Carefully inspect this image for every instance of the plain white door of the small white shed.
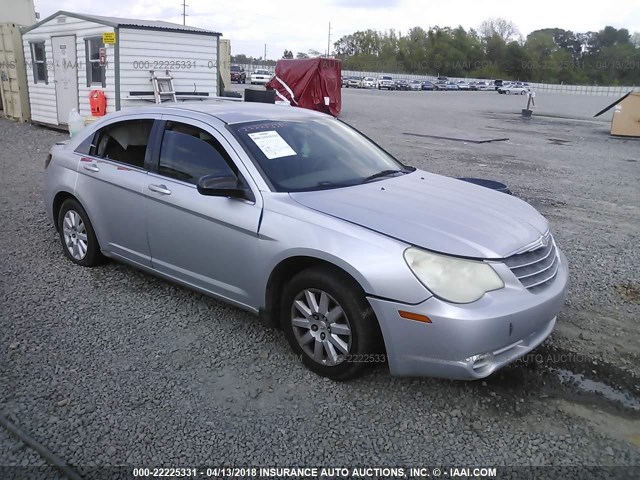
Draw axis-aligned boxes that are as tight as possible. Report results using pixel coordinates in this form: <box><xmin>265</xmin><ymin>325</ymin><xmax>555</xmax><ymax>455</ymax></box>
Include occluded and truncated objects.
<box><xmin>51</xmin><ymin>35</ymin><xmax>78</xmax><ymax>125</ymax></box>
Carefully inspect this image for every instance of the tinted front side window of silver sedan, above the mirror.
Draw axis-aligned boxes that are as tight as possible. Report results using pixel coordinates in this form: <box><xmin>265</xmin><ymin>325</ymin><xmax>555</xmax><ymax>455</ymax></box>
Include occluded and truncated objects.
<box><xmin>158</xmin><ymin>122</ymin><xmax>237</xmax><ymax>185</ymax></box>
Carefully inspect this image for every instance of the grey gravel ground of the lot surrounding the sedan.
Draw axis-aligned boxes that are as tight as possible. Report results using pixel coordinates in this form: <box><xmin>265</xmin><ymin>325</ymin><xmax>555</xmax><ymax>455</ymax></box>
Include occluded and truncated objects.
<box><xmin>0</xmin><ymin>89</ymin><xmax>640</xmax><ymax>476</ymax></box>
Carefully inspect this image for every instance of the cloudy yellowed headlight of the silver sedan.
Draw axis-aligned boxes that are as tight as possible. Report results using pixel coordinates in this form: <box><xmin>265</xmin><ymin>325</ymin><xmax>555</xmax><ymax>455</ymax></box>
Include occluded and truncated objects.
<box><xmin>404</xmin><ymin>247</ymin><xmax>504</xmax><ymax>303</ymax></box>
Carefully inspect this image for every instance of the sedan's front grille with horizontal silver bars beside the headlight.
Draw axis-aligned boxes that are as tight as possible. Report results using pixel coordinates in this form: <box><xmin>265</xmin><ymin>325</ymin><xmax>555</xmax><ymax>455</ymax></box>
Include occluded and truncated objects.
<box><xmin>504</xmin><ymin>232</ymin><xmax>559</xmax><ymax>293</ymax></box>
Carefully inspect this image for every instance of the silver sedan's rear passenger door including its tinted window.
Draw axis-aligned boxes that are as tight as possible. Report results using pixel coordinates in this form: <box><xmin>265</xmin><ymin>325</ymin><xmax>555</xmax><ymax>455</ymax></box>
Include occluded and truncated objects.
<box><xmin>76</xmin><ymin>115</ymin><xmax>159</xmax><ymax>267</ymax></box>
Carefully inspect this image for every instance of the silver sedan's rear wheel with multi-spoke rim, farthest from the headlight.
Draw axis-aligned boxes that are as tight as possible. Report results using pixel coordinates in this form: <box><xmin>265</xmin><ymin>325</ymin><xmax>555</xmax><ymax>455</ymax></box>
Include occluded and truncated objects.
<box><xmin>58</xmin><ymin>198</ymin><xmax>103</xmax><ymax>267</ymax></box>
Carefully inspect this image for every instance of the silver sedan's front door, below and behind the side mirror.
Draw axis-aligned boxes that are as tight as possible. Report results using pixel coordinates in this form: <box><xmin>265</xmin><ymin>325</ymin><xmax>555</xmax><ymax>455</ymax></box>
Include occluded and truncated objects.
<box><xmin>144</xmin><ymin>115</ymin><xmax>262</xmax><ymax>306</ymax></box>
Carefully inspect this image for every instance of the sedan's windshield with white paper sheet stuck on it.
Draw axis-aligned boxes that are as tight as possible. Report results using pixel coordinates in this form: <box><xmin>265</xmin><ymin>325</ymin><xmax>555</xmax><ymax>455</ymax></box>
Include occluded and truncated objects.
<box><xmin>228</xmin><ymin>118</ymin><xmax>411</xmax><ymax>192</ymax></box>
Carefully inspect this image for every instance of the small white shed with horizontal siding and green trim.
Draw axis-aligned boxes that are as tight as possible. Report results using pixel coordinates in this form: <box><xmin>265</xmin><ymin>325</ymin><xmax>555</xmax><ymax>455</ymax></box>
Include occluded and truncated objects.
<box><xmin>22</xmin><ymin>11</ymin><xmax>221</xmax><ymax>126</ymax></box>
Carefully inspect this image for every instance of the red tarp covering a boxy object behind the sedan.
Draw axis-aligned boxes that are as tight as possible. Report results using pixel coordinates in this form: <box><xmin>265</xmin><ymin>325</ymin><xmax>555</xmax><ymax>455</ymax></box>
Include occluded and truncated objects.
<box><xmin>266</xmin><ymin>58</ymin><xmax>342</xmax><ymax>117</ymax></box>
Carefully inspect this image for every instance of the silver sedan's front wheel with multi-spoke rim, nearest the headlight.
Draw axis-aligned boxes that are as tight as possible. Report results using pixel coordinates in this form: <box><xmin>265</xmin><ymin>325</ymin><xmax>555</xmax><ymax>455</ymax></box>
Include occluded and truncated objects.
<box><xmin>281</xmin><ymin>267</ymin><xmax>384</xmax><ymax>381</ymax></box>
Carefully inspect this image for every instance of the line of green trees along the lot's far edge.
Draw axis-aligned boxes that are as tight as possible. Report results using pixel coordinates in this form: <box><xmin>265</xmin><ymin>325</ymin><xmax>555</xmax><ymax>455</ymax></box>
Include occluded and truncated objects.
<box><xmin>330</xmin><ymin>18</ymin><xmax>640</xmax><ymax>85</ymax></box>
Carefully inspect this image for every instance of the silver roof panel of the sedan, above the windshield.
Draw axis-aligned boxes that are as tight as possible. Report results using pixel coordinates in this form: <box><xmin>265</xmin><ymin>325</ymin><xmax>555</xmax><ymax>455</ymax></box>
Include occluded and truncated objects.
<box><xmin>112</xmin><ymin>99</ymin><xmax>332</xmax><ymax>125</ymax></box>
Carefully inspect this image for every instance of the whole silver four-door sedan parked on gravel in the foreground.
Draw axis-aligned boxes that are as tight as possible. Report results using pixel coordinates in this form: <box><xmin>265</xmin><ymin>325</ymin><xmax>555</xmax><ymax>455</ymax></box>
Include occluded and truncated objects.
<box><xmin>44</xmin><ymin>102</ymin><xmax>567</xmax><ymax>380</ymax></box>
